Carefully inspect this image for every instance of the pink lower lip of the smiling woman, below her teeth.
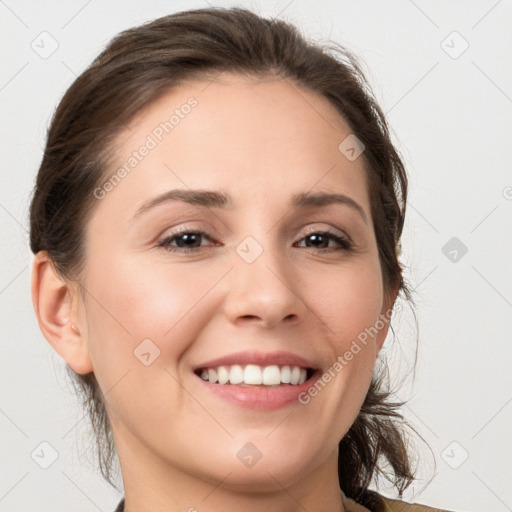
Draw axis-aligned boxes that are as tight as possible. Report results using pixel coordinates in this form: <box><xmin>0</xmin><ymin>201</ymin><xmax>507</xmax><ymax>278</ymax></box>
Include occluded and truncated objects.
<box><xmin>196</xmin><ymin>372</ymin><xmax>318</xmax><ymax>410</ymax></box>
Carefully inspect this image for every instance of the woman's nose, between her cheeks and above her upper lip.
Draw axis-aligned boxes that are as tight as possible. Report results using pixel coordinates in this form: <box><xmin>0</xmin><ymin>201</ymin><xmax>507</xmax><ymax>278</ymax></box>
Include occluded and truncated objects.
<box><xmin>224</xmin><ymin>243</ymin><xmax>306</xmax><ymax>329</ymax></box>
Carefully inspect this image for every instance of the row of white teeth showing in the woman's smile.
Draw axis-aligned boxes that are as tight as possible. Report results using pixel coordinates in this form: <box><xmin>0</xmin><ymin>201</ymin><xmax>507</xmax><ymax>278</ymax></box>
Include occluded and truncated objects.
<box><xmin>197</xmin><ymin>364</ymin><xmax>307</xmax><ymax>386</ymax></box>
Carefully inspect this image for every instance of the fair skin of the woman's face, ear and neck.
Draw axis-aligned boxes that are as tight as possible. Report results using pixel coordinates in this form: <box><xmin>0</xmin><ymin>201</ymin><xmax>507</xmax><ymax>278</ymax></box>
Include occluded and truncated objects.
<box><xmin>32</xmin><ymin>73</ymin><xmax>396</xmax><ymax>512</ymax></box>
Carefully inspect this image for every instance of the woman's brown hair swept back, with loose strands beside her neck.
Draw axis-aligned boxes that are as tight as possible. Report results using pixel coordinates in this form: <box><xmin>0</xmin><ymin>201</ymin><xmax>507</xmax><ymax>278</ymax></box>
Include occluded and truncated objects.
<box><xmin>30</xmin><ymin>8</ymin><xmax>424</xmax><ymax>505</ymax></box>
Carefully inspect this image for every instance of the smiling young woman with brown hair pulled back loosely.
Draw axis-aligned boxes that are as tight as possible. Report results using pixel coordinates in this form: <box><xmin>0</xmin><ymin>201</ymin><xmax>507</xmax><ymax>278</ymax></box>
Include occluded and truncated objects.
<box><xmin>30</xmin><ymin>8</ymin><xmax>454</xmax><ymax>512</ymax></box>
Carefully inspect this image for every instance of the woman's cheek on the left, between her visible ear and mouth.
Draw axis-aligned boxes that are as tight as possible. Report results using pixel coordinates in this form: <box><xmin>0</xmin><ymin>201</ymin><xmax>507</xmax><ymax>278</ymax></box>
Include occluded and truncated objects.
<box><xmin>80</xmin><ymin>257</ymin><xmax>225</xmax><ymax>431</ymax></box>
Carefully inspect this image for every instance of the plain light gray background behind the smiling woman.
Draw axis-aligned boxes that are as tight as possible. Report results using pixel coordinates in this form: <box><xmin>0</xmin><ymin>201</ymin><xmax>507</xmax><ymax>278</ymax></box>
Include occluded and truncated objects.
<box><xmin>0</xmin><ymin>0</ymin><xmax>512</xmax><ymax>512</ymax></box>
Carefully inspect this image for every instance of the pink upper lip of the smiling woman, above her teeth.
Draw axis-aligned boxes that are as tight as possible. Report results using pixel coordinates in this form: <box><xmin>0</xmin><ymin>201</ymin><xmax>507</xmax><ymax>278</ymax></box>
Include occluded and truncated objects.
<box><xmin>194</xmin><ymin>350</ymin><xmax>317</xmax><ymax>371</ymax></box>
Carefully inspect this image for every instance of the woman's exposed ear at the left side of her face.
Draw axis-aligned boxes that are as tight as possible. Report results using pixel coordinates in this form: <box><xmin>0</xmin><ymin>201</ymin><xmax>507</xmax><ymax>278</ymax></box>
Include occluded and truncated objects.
<box><xmin>32</xmin><ymin>251</ymin><xmax>93</xmax><ymax>374</ymax></box>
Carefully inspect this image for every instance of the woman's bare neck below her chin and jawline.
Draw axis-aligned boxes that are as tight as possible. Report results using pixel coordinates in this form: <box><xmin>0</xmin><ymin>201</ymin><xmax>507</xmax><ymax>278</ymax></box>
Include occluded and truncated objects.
<box><xmin>116</xmin><ymin>424</ymin><xmax>346</xmax><ymax>512</ymax></box>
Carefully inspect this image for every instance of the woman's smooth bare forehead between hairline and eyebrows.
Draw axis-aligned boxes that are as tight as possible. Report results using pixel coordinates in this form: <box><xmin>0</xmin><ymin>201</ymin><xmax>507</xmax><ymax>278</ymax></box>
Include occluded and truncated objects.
<box><xmin>95</xmin><ymin>73</ymin><xmax>368</xmax><ymax>214</ymax></box>
